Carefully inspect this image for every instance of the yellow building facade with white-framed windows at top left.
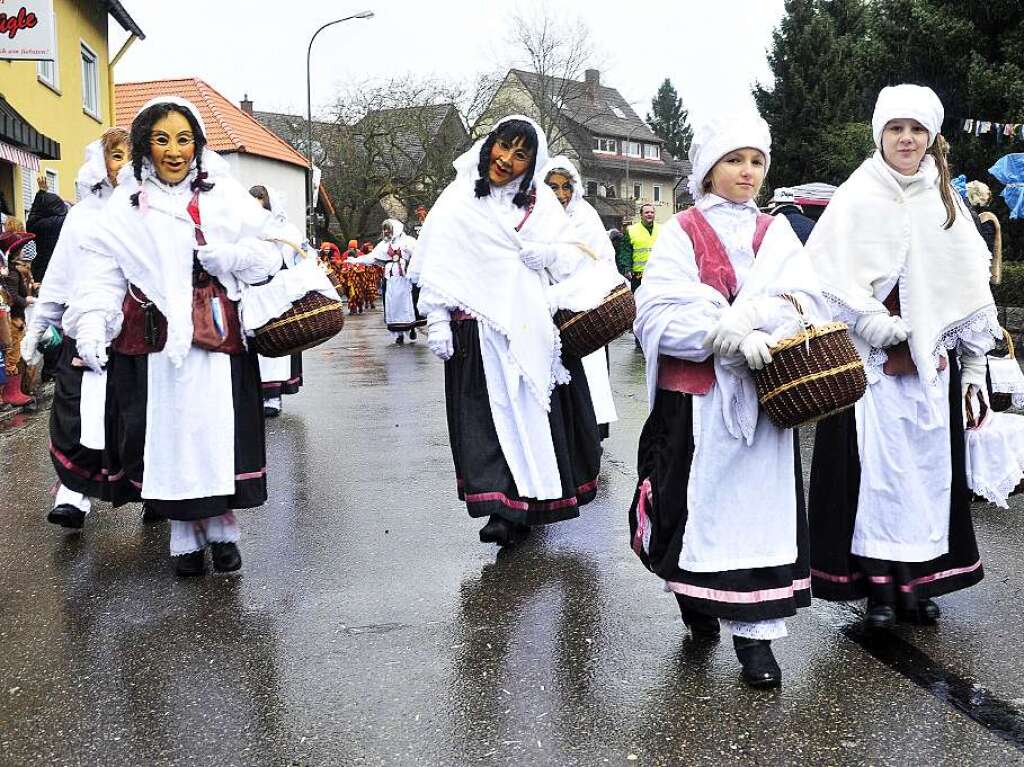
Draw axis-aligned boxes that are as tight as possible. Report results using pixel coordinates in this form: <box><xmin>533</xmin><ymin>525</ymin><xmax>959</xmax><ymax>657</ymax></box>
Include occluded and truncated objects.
<box><xmin>0</xmin><ymin>0</ymin><xmax>143</xmax><ymax>215</ymax></box>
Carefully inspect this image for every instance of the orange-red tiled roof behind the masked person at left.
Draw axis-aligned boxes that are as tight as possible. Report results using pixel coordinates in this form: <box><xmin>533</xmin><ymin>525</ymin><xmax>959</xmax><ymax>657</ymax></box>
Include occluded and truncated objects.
<box><xmin>115</xmin><ymin>77</ymin><xmax>308</xmax><ymax>168</ymax></box>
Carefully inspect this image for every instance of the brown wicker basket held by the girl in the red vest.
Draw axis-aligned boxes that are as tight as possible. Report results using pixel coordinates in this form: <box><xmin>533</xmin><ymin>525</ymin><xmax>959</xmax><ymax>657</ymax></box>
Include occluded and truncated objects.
<box><xmin>754</xmin><ymin>323</ymin><xmax>867</xmax><ymax>429</ymax></box>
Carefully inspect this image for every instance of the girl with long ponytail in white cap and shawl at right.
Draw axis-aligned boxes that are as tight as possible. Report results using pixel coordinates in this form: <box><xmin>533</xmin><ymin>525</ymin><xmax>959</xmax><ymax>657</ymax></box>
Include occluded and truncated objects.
<box><xmin>807</xmin><ymin>85</ymin><xmax>1001</xmax><ymax>629</ymax></box>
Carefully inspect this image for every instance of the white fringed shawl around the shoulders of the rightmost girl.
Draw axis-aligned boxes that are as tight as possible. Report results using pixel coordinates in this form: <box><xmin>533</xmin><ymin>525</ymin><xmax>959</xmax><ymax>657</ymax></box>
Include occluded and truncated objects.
<box><xmin>807</xmin><ymin>153</ymin><xmax>1000</xmax><ymax>384</ymax></box>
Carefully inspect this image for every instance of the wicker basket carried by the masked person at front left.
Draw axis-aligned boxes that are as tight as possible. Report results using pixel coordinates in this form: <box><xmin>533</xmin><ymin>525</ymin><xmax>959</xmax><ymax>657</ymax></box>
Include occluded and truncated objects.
<box><xmin>249</xmin><ymin>240</ymin><xmax>345</xmax><ymax>357</ymax></box>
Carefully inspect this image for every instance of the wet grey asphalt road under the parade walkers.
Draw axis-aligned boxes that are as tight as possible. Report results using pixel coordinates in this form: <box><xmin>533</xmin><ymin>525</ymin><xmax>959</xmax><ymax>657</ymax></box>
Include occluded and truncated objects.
<box><xmin>0</xmin><ymin>312</ymin><xmax>1024</xmax><ymax>767</ymax></box>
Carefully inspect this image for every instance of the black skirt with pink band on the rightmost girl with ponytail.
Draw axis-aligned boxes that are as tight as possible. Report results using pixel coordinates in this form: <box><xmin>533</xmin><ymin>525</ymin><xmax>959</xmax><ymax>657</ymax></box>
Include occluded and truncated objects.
<box><xmin>809</xmin><ymin>354</ymin><xmax>984</xmax><ymax>609</ymax></box>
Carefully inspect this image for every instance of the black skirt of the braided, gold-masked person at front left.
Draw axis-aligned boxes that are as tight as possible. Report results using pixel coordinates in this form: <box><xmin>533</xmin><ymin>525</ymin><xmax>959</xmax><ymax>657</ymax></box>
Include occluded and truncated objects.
<box><xmin>105</xmin><ymin>351</ymin><xmax>267</xmax><ymax>520</ymax></box>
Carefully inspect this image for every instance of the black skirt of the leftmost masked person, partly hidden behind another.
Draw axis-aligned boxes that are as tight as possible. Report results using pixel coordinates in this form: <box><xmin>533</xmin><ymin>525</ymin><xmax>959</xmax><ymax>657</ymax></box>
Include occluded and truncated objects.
<box><xmin>50</xmin><ymin>337</ymin><xmax>110</xmax><ymax>501</ymax></box>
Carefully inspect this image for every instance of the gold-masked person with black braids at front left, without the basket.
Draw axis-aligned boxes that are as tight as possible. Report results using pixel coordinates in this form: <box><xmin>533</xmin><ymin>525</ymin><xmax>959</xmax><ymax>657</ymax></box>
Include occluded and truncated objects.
<box><xmin>65</xmin><ymin>96</ymin><xmax>282</xmax><ymax>576</ymax></box>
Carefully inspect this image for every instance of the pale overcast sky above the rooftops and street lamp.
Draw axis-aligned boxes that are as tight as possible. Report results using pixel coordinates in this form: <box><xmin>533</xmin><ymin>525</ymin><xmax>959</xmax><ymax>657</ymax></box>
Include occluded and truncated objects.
<box><xmin>112</xmin><ymin>0</ymin><xmax>782</xmax><ymax>128</ymax></box>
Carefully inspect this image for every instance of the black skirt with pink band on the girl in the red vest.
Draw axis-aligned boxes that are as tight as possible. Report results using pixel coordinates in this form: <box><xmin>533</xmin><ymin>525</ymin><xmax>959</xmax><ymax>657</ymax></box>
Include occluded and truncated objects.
<box><xmin>630</xmin><ymin>389</ymin><xmax>811</xmax><ymax>622</ymax></box>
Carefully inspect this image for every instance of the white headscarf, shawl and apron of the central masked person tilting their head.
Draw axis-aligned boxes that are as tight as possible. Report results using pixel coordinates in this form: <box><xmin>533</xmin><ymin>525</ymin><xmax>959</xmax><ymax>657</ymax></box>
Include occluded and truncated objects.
<box><xmin>415</xmin><ymin>116</ymin><xmax>584</xmax><ymax>500</ymax></box>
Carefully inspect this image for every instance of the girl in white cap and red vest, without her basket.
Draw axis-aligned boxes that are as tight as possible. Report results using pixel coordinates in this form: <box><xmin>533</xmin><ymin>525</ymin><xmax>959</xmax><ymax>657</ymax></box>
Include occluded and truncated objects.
<box><xmin>630</xmin><ymin>114</ymin><xmax>828</xmax><ymax>687</ymax></box>
